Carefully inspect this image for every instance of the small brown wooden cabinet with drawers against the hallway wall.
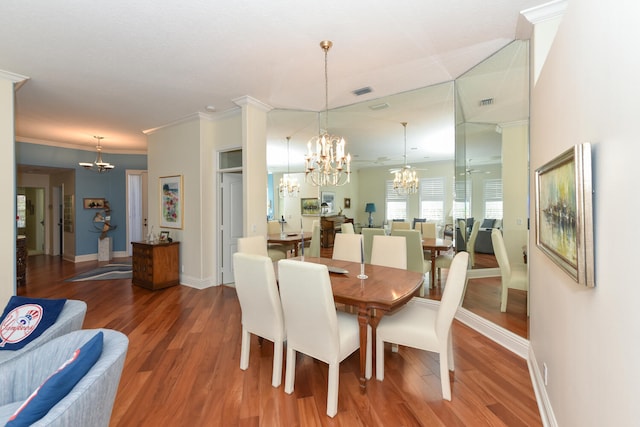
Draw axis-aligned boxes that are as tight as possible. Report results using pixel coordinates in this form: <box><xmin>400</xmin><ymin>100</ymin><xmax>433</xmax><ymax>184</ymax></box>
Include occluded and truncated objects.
<box><xmin>131</xmin><ymin>242</ymin><xmax>180</xmax><ymax>290</ymax></box>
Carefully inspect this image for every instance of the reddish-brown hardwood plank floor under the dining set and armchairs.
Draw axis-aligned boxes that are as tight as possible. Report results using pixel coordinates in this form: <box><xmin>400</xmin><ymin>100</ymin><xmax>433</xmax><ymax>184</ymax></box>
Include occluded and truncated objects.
<box><xmin>18</xmin><ymin>255</ymin><xmax>542</xmax><ymax>427</ymax></box>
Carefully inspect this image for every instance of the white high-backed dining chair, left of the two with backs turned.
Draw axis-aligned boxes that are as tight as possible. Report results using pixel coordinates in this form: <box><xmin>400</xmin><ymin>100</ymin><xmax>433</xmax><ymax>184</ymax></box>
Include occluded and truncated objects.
<box><xmin>233</xmin><ymin>252</ymin><xmax>286</xmax><ymax>387</ymax></box>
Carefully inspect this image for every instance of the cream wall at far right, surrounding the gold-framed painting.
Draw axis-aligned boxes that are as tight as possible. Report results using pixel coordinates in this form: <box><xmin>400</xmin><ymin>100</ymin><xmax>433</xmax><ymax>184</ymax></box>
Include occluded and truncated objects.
<box><xmin>529</xmin><ymin>0</ymin><xmax>640</xmax><ymax>427</ymax></box>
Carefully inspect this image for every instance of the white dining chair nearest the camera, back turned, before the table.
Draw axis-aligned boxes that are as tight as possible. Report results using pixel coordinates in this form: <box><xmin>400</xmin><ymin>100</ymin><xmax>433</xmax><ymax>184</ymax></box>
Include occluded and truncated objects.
<box><xmin>278</xmin><ymin>260</ymin><xmax>371</xmax><ymax>417</ymax></box>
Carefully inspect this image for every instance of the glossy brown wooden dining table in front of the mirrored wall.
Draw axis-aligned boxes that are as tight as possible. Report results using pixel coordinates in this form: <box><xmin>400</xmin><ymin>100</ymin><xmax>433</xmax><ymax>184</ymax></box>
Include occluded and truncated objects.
<box><xmin>274</xmin><ymin>257</ymin><xmax>424</xmax><ymax>391</ymax></box>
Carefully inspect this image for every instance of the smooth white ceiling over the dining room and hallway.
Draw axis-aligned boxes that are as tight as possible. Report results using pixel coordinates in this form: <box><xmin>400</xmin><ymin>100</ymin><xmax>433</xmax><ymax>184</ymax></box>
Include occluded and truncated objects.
<box><xmin>0</xmin><ymin>0</ymin><xmax>548</xmax><ymax>162</ymax></box>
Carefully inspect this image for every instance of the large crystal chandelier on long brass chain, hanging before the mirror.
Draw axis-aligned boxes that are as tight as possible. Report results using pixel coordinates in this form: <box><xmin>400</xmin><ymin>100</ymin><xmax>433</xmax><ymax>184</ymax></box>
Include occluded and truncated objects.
<box><xmin>304</xmin><ymin>40</ymin><xmax>351</xmax><ymax>187</ymax></box>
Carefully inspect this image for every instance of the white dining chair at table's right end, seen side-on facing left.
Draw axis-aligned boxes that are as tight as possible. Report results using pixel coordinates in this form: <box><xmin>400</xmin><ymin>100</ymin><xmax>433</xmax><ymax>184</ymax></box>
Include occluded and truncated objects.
<box><xmin>376</xmin><ymin>252</ymin><xmax>469</xmax><ymax>400</ymax></box>
